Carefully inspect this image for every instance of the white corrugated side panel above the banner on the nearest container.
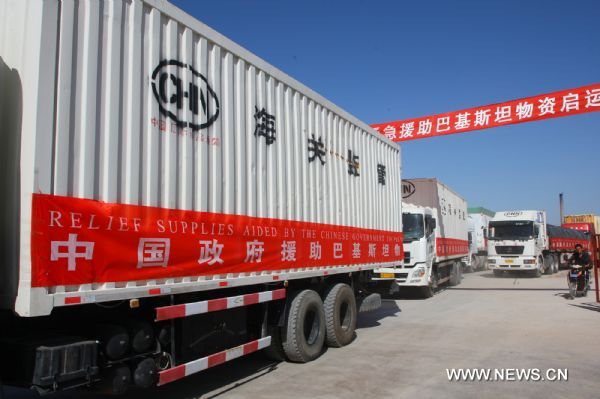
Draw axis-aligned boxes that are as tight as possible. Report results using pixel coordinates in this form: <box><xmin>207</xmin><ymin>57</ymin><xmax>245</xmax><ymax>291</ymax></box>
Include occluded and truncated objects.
<box><xmin>42</xmin><ymin>0</ymin><xmax>399</xmax><ymax>229</ymax></box>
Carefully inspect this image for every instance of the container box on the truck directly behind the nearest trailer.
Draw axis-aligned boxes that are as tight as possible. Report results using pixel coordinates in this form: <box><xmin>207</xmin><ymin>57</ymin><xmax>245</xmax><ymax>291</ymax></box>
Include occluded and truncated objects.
<box><xmin>403</xmin><ymin>179</ymin><xmax>468</xmax><ymax>260</ymax></box>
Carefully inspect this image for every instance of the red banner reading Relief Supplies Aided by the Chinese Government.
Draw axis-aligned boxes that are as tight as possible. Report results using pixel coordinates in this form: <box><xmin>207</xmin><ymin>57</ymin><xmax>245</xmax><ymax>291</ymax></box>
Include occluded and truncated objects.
<box><xmin>31</xmin><ymin>194</ymin><xmax>404</xmax><ymax>287</ymax></box>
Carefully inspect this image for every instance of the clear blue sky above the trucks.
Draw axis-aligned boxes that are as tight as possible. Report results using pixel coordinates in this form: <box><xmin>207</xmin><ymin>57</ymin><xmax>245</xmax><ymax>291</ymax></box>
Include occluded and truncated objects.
<box><xmin>173</xmin><ymin>0</ymin><xmax>600</xmax><ymax>223</ymax></box>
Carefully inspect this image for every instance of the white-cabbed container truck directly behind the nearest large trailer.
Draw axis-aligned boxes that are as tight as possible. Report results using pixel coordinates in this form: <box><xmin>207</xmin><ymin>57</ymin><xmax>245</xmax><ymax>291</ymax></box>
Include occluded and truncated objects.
<box><xmin>374</xmin><ymin>179</ymin><xmax>469</xmax><ymax>297</ymax></box>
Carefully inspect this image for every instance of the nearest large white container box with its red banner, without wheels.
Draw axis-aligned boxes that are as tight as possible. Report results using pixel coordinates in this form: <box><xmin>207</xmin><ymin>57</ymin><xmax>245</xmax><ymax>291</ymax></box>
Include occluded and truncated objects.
<box><xmin>0</xmin><ymin>0</ymin><xmax>404</xmax><ymax>316</ymax></box>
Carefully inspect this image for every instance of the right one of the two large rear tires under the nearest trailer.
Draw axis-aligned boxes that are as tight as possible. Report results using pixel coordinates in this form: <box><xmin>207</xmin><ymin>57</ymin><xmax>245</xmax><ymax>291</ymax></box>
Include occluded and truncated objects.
<box><xmin>323</xmin><ymin>283</ymin><xmax>358</xmax><ymax>348</ymax></box>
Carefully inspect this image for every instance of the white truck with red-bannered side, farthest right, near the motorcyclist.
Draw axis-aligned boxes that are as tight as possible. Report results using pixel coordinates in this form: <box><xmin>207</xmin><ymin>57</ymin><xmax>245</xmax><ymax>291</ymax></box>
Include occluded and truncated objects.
<box><xmin>488</xmin><ymin>210</ymin><xmax>590</xmax><ymax>277</ymax></box>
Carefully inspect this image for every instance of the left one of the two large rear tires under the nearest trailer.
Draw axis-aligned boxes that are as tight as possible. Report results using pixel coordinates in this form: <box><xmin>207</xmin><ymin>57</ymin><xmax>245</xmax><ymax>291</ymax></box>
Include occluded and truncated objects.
<box><xmin>283</xmin><ymin>290</ymin><xmax>325</xmax><ymax>363</ymax></box>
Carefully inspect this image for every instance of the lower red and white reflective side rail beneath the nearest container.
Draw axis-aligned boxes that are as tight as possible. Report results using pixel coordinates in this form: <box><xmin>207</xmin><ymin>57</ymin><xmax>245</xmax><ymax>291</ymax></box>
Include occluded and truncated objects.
<box><xmin>158</xmin><ymin>337</ymin><xmax>271</xmax><ymax>386</ymax></box>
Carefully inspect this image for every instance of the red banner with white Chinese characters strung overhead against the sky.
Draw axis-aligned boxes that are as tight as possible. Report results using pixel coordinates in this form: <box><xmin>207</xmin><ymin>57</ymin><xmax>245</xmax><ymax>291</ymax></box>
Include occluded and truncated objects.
<box><xmin>371</xmin><ymin>83</ymin><xmax>600</xmax><ymax>141</ymax></box>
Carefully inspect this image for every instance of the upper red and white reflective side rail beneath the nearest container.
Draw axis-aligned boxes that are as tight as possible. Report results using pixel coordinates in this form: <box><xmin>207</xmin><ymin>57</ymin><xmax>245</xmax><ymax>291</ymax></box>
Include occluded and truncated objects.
<box><xmin>156</xmin><ymin>288</ymin><xmax>285</xmax><ymax>321</ymax></box>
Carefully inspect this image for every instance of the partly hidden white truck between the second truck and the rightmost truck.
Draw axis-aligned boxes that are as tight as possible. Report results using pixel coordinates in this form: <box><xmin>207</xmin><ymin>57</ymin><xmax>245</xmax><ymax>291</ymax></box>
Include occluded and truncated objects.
<box><xmin>467</xmin><ymin>206</ymin><xmax>496</xmax><ymax>271</ymax></box>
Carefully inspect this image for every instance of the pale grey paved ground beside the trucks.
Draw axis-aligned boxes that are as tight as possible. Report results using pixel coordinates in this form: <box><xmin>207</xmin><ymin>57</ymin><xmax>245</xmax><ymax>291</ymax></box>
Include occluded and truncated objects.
<box><xmin>7</xmin><ymin>272</ymin><xmax>600</xmax><ymax>399</ymax></box>
